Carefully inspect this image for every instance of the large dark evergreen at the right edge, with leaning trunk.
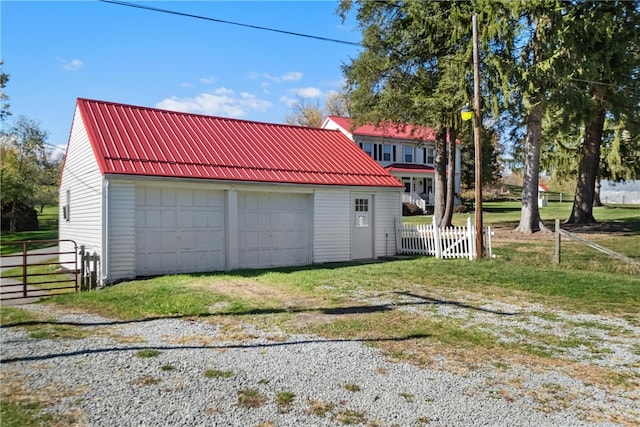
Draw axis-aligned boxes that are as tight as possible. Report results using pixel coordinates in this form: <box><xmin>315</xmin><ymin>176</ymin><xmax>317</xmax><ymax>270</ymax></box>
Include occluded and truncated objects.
<box><xmin>558</xmin><ymin>1</ymin><xmax>640</xmax><ymax>224</ymax></box>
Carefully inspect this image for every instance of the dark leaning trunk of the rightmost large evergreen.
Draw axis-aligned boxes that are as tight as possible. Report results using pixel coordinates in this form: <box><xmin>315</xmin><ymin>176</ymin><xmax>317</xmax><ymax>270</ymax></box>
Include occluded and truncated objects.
<box><xmin>567</xmin><ymin>106</ymin><xmax>606</xmax><ymax>224</ymax></box>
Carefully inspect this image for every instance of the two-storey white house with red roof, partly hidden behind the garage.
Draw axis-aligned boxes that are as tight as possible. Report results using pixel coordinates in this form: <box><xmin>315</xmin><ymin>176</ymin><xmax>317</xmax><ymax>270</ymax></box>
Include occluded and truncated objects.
<box><xmin>322</xmin><ymin>116</ymin><xmax>460</xmax><ymax>209</ymax></box>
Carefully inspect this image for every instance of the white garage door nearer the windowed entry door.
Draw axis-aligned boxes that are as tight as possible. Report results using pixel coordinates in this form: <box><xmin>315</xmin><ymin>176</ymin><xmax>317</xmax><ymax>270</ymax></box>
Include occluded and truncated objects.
<box><xmin>238</xmin><ymin>192</ymin><xmax>311</xmax><ymax>268</ymax></box>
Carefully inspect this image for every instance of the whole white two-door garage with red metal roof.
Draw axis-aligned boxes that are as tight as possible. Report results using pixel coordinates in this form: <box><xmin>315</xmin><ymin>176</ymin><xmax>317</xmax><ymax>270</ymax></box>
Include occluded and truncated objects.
<box><xmin>59</xmin><ymin>99</ymin><xmax>402</xmax><ymax>284</ymax></box>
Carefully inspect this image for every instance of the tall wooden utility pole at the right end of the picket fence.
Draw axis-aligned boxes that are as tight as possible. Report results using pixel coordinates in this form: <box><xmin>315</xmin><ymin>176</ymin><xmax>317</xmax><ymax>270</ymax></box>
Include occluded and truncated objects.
<box><xmin>472</xmin><ymin>14</ymin><xmax>484</xmax><ymax>259</ymax></box>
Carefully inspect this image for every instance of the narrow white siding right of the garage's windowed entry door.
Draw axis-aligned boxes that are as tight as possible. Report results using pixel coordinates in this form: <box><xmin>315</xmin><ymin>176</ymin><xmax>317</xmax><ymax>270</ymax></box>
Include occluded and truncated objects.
<box><xmin>373</xmin><ymin>190</ymin><xmax>402</xmax><ymax>258</ymax></box>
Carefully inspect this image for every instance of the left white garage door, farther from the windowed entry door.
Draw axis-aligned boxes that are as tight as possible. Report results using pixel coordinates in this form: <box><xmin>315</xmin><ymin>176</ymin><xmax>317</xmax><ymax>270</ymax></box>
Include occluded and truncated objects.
<box><xmin>136</xmin><ymin>187</ymin><xmax>225</xmax><ymax>276</ymax></box>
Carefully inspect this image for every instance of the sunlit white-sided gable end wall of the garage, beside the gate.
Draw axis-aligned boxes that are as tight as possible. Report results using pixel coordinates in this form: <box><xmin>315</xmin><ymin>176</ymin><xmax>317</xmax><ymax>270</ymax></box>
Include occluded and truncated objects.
<box><xmin>59</xmin><ymin>108</ymin><xmax>102</xmax><ymax>268</ymax></box>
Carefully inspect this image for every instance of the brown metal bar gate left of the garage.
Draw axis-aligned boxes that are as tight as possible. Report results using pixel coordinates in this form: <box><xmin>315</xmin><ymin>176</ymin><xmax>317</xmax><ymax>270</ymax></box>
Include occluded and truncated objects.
<box><xmin>0</xmin><ymin>240</ymin><xmax>79</xmax><ymax>304</ymax></box>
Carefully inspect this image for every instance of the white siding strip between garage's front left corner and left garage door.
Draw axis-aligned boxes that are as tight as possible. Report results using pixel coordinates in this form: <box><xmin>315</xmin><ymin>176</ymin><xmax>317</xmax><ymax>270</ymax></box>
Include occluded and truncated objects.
<box><xmin>107</xmin><ymin>181</ymin><xmax>136</xmax><ymax>282</ymax></box>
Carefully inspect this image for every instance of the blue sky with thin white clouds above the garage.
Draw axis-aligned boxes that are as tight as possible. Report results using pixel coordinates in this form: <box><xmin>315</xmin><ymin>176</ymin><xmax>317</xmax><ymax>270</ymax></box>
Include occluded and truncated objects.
<box><xmin>0</xmin><ymin>0</ymin><xmax>360</xmax><ymax>154</ymax></box>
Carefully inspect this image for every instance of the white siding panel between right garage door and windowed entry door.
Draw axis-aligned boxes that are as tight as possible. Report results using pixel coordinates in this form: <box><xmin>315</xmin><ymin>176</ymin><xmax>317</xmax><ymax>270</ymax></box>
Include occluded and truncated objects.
<box><xmin>313</xmin><ymin>190</ymin><xmax>350</xmax><ymax>263</ymax></box>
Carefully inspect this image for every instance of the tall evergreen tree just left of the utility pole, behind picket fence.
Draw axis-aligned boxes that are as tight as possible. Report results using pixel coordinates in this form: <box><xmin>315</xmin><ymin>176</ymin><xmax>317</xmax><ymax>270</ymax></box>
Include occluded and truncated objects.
<box><xmin>339</xmin><ymin>0</ymin><xmax>471</xmax><ymax>225</ymax></box>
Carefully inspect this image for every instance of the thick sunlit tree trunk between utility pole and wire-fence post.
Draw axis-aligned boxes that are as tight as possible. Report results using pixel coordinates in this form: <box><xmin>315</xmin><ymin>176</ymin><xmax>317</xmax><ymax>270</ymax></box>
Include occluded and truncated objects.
<box><xmin>516</xmin><ymin>101</ymin><xmax>546</xmax><ymax>234</ymax></box>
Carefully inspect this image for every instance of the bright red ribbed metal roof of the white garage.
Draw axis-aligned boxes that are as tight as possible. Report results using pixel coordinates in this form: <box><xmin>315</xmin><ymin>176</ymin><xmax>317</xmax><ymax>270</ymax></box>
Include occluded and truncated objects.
<box><xmin>77</xmin><ymin>99</ymin><xmax>401</xmax><ymax>187</ymax></box>
